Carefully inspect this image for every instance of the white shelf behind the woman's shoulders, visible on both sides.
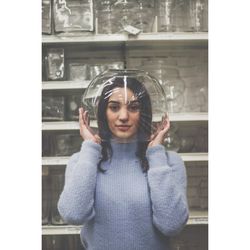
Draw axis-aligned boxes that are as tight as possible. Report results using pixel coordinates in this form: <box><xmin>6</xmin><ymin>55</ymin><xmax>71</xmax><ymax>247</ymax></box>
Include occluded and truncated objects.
<box><xmin>42</xmin><ymin>153</ymin><xmax>208</xmax><ymax>166</ymax></box>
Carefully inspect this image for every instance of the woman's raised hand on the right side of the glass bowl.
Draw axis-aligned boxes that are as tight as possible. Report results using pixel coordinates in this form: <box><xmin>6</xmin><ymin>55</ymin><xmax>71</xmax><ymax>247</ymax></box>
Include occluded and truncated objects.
<box><xmin>148</xmin><ymin>115</ymin><xmax>170</xmax><ymax>147</ymax></box>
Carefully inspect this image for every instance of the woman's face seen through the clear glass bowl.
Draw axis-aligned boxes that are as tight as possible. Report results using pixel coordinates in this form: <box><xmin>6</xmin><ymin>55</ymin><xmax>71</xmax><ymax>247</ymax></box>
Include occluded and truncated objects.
<box><xmin>106</xmin><ymin>88</ymin><xmax>140</xmax><ymax>139</ymax></box>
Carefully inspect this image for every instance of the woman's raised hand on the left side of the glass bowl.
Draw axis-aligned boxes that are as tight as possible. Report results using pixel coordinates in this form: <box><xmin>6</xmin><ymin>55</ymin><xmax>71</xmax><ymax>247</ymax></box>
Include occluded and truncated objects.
<box><xmin>79</xmin><ymin>108</ymin><xmax>101</xmax><ymax>144</ymax></box>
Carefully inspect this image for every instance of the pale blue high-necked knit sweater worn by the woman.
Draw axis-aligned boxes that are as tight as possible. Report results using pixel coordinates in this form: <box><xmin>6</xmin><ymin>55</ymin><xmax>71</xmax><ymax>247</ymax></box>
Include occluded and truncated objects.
<box><xmin>58</xmin><ymin>141</ymin><xmax>188</xmax><ymax>250</ymax></box>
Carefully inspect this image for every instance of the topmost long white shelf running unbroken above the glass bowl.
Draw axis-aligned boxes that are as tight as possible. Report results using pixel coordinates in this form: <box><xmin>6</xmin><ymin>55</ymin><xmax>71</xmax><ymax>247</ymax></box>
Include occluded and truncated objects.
<box><xmin>42</xmin><ymin>32</ymin><xmax>208</xmax><ymax>44</ymax></box>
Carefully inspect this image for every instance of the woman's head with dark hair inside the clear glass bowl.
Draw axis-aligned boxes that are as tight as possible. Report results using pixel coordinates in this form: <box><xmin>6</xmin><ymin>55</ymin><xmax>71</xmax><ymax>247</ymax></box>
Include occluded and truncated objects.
<box><xmin>97</xmin><ymin>76</ymin><xmax>152</xmax><ymax>141</ymax></box>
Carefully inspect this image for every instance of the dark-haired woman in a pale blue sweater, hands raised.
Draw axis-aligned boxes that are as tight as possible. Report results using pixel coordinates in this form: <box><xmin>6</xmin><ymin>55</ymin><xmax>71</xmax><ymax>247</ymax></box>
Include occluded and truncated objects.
<box><xmin>58</xmin><ymin>77</ymin><xmax>188</xmax><ymax>250</ymax></box>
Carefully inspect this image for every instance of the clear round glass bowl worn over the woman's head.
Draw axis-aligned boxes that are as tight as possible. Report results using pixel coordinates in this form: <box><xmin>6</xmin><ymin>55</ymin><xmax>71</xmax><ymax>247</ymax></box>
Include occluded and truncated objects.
<box><xmin>82</xmin><ymin>69</ymin><xmax>167</xmax><ymax>141</ymax></box>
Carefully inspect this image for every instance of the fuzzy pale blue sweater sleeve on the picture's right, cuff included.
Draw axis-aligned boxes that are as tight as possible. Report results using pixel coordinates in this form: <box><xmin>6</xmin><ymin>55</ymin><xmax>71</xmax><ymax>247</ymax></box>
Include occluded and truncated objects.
<box><xmin>146</xmin><ymin>145</ymin><xmax>189</xmax><ymax>236</ymax></box>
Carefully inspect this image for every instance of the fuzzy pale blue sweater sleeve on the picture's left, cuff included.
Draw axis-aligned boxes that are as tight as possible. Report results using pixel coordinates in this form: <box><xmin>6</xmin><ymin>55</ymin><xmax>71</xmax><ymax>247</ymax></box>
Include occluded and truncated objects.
<box><xmin>58</xmin><ymin>140</ymin><xmax>101</xmax><ymax>225</ymax></box>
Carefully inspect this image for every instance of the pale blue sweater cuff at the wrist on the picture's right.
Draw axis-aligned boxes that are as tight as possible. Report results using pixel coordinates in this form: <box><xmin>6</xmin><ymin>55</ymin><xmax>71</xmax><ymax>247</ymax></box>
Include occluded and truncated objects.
<box><xmin>146</xmin><ymin>145</ymin><xmax>167</xmax><ymax>168</ymax></box>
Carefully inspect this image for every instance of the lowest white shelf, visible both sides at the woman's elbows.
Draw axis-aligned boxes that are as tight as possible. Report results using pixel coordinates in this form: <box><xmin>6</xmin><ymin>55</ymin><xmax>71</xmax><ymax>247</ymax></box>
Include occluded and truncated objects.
<box><xmin>42</xmin><ymin>211</ymin><xmax>208</xmax><ymax>235</ymax></box>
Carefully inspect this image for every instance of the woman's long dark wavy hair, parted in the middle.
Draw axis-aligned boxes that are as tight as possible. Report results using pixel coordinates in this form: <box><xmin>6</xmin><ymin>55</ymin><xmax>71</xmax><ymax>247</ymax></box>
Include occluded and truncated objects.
<box><xmin>97</xmin><ymin>76</ymin><xmax>152</xmax><ymax>172</ymax></box>
